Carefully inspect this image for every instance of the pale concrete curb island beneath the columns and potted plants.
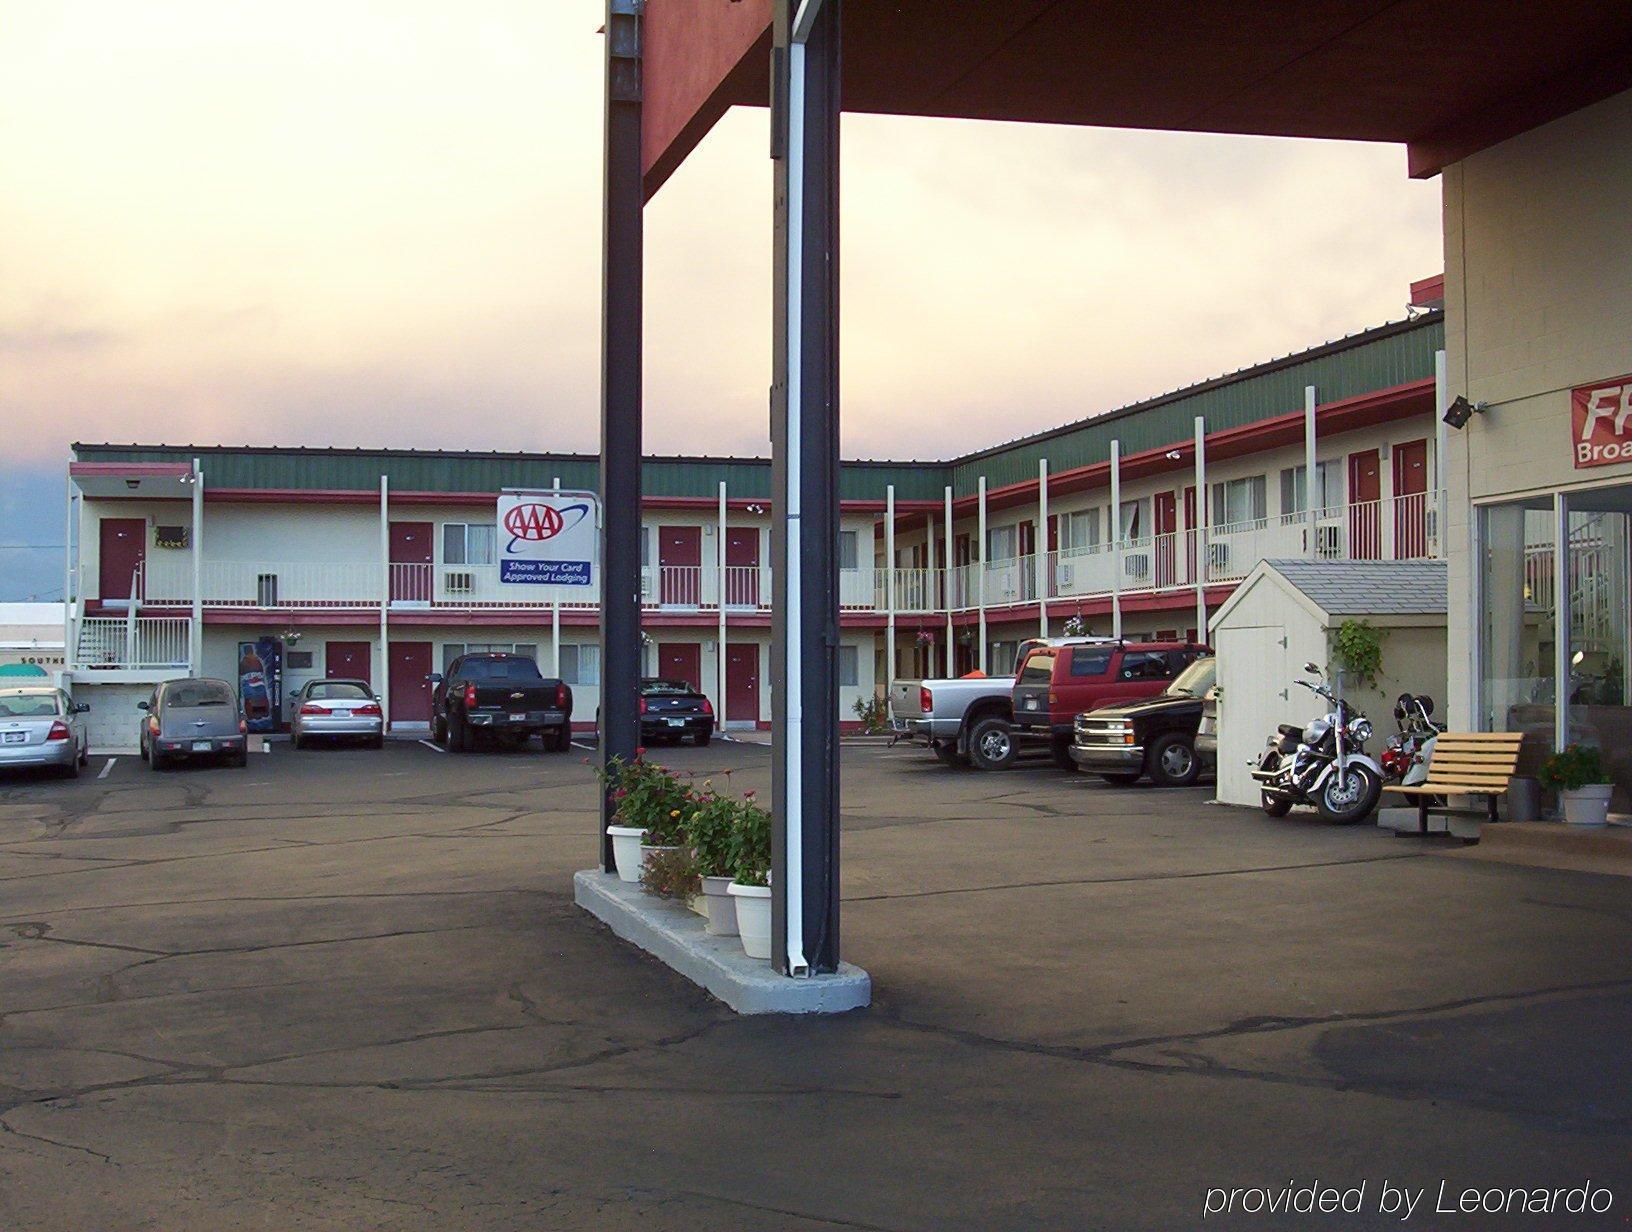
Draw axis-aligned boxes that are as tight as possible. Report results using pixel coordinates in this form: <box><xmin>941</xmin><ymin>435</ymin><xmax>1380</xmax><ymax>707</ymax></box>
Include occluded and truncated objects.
<box><xmin>573</xmin><ymin>868</ymin><xmax>873</xmax><ymax>1013</ymax></box>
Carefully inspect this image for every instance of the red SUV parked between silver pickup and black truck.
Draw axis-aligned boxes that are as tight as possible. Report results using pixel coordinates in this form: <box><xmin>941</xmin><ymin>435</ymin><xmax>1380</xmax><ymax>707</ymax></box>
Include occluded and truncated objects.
<box><xmin>1013</xmin><ymin>641</ymin><xmax>1211</xmax><ymax>770</ymax></box>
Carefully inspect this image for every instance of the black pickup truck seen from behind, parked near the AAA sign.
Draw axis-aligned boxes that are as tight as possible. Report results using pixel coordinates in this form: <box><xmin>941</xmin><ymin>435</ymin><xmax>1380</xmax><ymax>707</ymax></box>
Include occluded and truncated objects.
<box><xmin>431</xmin><ymin>653</ymin><xmax>573</xmax><ymax>752</ymax></box>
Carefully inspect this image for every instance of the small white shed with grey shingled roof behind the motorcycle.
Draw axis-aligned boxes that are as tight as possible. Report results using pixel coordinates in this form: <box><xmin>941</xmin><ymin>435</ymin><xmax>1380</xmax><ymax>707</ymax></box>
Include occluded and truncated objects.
<box><xmin>1208</xmin><ymin>560</ymin><xmax>1446</xmax><ymax>804</ymax></box>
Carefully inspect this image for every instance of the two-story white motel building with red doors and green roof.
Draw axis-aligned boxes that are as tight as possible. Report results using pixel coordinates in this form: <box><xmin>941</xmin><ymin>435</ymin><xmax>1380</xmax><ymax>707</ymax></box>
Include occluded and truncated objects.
<box><xmin>65</xmin><ymin>308</ymin><xmax>1444</xmax><ymax>747</ymax></box>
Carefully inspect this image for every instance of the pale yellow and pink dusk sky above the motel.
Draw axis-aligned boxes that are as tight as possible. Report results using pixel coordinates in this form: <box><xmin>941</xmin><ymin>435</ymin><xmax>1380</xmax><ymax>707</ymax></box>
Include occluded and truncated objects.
<box><xmin>0</xmin><ymin>0</ymin><xmax>1441</xmax><ymax>597</ymax></box>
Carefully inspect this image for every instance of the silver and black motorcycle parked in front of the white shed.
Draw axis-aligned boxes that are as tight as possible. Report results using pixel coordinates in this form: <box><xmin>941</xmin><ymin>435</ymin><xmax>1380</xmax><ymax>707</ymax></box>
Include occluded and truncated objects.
<box><xmin>1252</xmin><ymin>663</ymin><xmax>1382</xmax><ymax>826</ymax></box>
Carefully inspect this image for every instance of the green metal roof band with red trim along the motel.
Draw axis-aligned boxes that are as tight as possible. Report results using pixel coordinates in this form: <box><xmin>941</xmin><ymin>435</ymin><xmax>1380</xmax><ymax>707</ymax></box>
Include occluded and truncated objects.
<box><xmin>73</xmin><ymin>312</ymin><xmax>1444</xmax><ymax>501</ymax></box>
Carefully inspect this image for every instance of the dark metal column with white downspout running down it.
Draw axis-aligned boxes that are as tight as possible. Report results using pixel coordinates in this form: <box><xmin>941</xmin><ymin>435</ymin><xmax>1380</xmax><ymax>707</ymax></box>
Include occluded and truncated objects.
<box><xmin>770</xmin><ymin>0</ymin><xmax>840</xmax><ymax>976</ymax></box>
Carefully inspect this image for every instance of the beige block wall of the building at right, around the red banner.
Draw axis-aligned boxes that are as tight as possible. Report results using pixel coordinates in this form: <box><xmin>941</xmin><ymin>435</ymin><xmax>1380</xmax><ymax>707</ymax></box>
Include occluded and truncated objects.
<box><xmin>1443</xmin><ymin>91</ymin><xmax>1632</xmax><ymax>728</ymax></box>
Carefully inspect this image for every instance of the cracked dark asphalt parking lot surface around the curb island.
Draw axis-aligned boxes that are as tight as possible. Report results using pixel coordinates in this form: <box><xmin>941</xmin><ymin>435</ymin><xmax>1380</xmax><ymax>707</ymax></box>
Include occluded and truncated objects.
<box><xmin>0</xmin><ymin>741</ymin><xmax>1632</xmax><ymax>1232</ymax></box>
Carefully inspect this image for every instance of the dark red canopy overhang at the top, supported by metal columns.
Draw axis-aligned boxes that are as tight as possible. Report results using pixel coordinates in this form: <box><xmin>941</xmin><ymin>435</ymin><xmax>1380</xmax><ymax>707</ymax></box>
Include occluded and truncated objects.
<box><xmin>641</xmin><ymin>0</ymin><xmax>1632</xmax><ymax>199</ymax></box>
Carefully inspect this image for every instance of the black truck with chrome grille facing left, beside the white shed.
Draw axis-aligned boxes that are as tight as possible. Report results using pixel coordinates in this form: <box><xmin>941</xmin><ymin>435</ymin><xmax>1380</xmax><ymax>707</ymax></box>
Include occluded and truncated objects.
<box><xmin>1071</xmin><ymin>654</ymin><xmax>1217</xmax><ymax>787</ymax></box>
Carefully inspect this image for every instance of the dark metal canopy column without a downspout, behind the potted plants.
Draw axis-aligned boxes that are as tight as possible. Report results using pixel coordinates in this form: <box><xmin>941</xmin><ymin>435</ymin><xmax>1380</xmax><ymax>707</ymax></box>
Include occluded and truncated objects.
<box><xmin>601</xmin><ymin>0</ymin><xmax>645</xmax><ymax>873</ymax></box>
